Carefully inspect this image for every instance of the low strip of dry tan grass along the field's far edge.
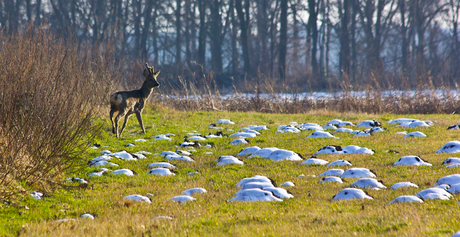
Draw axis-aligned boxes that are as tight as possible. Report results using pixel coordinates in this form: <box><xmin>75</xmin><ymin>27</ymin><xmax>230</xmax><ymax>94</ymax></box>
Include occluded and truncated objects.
<box><xmin>155</xmin><ymin>90</ymin><xmax>460</xmax><ymax>114</ymax></box>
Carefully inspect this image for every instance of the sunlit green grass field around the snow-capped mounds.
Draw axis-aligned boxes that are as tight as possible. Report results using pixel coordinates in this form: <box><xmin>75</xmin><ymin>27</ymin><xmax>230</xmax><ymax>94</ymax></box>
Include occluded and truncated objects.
<box><xmin>0</xmin><ymin>110</ymin><xmax>460</xmax><ymax>236</ymax></box>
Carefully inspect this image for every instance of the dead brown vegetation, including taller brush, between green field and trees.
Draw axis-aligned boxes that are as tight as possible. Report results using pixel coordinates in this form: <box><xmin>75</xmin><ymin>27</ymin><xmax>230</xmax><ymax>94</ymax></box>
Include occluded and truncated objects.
<box><xmin>151</xmin><ymin>74</ymin><xmax>460</xmax><ymax>114</ymax></box>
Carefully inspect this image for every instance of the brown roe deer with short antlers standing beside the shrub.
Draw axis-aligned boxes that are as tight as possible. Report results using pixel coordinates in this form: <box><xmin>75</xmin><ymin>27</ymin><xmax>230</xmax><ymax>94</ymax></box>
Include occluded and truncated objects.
<box><xmin>110</xmin><ymin>63</ymin><xmax>160</xmax><ymax>138</ymax></box>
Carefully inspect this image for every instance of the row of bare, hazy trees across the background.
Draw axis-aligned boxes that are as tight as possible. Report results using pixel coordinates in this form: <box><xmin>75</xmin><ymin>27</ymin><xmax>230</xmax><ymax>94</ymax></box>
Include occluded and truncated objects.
<box><xmin>0</xmin><ymin>0</ymin><xmax>460</xmax><ymax>90</ymax></box>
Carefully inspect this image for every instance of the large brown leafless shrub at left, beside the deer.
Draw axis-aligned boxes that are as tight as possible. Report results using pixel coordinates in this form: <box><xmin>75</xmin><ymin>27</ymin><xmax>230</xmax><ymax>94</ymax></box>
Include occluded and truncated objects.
<box><xmin>0</xmin><ymin>27</ymin><xmax>120</xmax><ymax>198</ymax></box>
